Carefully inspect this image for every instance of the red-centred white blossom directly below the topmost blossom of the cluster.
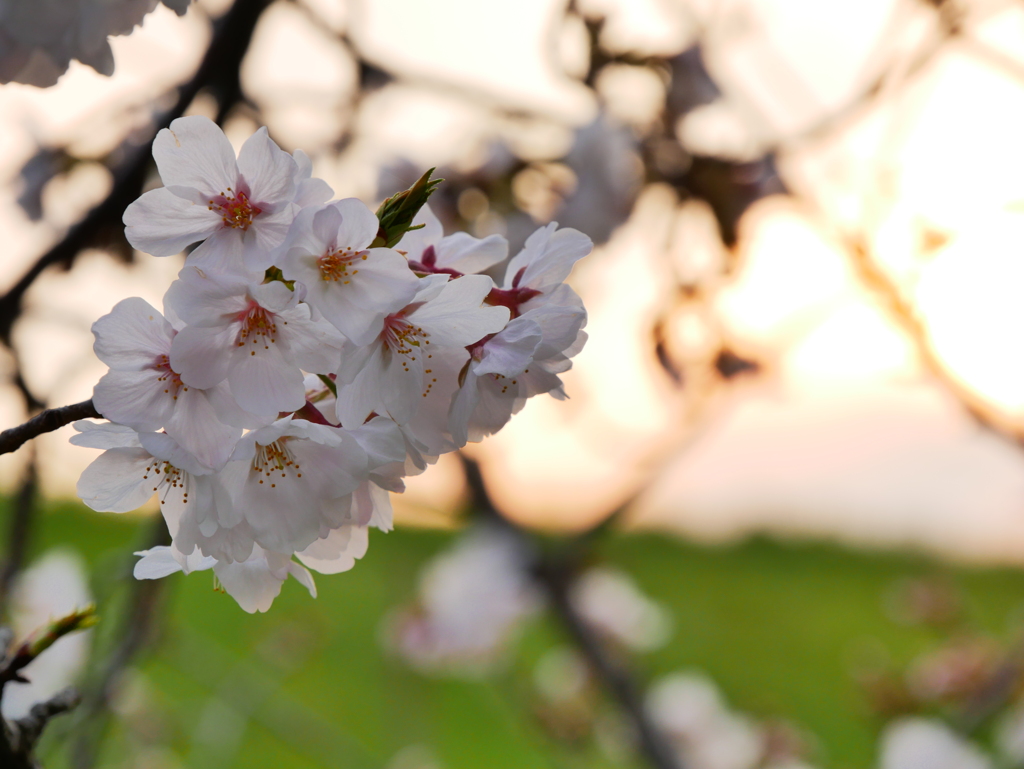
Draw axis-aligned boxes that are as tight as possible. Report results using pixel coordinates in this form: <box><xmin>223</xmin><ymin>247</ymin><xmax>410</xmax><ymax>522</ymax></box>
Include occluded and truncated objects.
<box><xmin>166</xmin><ymin>264</ymin><xmax>343</xmax><ymax>416</ymax></box>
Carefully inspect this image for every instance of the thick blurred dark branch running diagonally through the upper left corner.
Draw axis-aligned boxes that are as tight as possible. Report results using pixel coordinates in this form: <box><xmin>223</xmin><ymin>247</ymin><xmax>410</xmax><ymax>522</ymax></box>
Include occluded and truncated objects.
<box><xmin>0</xmin><ymin>0</ymin><xmax>269</xmax><ymax>345</ymax></box>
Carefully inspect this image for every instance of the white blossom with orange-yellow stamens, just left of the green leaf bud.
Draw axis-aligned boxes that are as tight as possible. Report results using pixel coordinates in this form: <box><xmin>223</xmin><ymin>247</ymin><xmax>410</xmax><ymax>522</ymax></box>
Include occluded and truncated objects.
<box><xmin>276</xmin><ymin>198</ymin><xmax>418</xmax><ymax>345</ymax></box>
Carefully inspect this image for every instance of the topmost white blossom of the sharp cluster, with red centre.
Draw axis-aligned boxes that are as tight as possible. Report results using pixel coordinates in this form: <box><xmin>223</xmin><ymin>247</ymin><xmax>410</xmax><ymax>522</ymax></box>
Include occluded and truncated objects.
<box><xmin>124</xmin><ymin>116</ymin><xmax>301</xmax><ymax>272</ymax></box>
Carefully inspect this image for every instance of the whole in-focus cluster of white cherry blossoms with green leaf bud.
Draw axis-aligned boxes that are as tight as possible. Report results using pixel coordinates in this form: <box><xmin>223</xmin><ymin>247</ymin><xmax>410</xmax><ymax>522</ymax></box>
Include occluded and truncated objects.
<box><xmin>72</xmin><ymin>117</ymin><xmax>591</xmax><ymax>612</ymax></box>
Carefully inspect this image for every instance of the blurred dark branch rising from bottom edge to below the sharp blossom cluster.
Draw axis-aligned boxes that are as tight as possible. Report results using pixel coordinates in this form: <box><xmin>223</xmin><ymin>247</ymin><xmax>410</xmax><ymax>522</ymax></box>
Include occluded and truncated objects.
<box><xmin>460</xmin><ymin>455</ymin><xmax>685</xmax><ymax>769</ymax></box>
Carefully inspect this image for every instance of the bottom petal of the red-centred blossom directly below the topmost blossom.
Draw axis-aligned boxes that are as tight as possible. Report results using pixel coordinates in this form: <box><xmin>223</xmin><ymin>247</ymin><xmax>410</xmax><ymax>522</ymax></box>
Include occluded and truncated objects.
<box><xmin>225</xmin><ymin>342</ymin><xmax>306</xmax><ymax>415</ymax></box>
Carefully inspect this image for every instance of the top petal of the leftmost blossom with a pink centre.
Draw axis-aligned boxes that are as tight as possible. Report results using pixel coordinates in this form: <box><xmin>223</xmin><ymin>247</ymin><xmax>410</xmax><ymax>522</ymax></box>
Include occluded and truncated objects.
<box><xmin>92</xmin><ymin>296</ymin><xmax>174</xmax><ymax>371</ymax></box>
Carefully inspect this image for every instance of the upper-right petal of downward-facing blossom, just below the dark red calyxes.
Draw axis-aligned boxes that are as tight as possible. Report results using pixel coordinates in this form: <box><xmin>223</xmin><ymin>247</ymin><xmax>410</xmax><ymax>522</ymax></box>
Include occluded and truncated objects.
<box><xmin>410</xmin><ymin>275</ymin><xmax>510</xmax><ymax>347</ymax></box>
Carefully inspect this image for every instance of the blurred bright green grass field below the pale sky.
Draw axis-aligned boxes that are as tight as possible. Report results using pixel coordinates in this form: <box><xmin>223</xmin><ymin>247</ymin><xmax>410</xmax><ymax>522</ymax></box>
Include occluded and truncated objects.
<box><xmin>8</xmin><ymin>504</ymin><xmax>1024</xmax><ymax>769</ymax></box>
